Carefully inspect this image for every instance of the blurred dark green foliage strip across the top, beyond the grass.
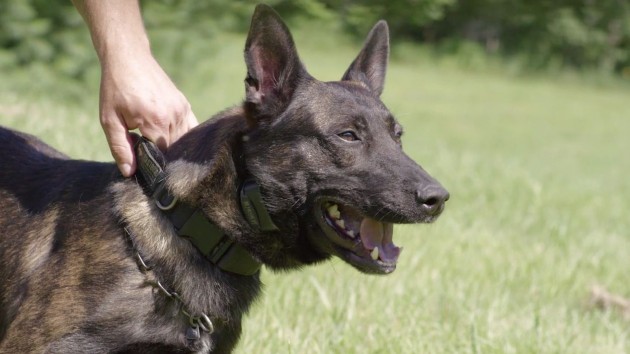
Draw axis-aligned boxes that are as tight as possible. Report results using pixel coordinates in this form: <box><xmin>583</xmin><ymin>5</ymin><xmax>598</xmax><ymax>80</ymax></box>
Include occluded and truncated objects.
<box><xmin>0</xmin><ymin>0</ymin><xmax>630</xmax><ymax>77</ymax></box>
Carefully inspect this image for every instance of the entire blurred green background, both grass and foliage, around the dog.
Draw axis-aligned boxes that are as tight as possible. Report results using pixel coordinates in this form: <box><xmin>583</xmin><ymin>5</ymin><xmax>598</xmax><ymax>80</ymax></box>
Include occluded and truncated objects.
<box><xmin>0</xmin><ymin>0</ymin><xmax>630</xmax><ymax>353</ymax></box>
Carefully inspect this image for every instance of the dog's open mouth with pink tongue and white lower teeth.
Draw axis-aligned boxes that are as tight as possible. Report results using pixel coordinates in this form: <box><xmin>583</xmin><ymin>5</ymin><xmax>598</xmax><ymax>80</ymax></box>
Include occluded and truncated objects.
<box><xmin>316</xmin><ymin>201</ymin><xmax>401</xmax><ymax>274</ymax></box>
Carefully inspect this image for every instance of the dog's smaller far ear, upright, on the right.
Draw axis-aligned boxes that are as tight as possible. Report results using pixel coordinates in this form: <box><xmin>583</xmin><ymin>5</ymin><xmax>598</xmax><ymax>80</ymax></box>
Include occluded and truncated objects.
<box><xmin>342</xmin><ymin>20</ymin><xmax>389</xmax><ymax>96</ymax></box>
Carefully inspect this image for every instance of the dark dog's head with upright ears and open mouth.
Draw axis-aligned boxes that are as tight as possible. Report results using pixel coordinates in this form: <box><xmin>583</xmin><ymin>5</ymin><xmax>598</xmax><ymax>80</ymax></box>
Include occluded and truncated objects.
<box><xmin>237</xmin><ymin>6</ymin><xmax>449</xmax><ymax>274</ymax></box>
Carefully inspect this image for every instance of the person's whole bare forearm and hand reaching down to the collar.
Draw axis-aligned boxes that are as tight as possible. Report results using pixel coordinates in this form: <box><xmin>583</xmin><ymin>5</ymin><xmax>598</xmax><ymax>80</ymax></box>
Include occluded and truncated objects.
<box><xmin>72</xmin><ymin>0</ymin><xmax>197</xmax><ymax>177</ymax></box>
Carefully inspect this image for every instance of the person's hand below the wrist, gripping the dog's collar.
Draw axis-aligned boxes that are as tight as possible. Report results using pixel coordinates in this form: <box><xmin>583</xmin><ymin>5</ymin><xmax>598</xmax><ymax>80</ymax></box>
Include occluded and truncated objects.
<box><xmin>99</xmin><ymin>53</ymin><xmax>198</xmax><ymax>177</ymax></box>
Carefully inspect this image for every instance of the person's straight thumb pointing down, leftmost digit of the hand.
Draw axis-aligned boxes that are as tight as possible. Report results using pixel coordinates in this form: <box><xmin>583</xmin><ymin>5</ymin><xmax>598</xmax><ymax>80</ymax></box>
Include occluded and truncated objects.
<box><xmin>101</xmin><ymin>115</ymin><xmax>136</xmax><ymax>177</ymax></box>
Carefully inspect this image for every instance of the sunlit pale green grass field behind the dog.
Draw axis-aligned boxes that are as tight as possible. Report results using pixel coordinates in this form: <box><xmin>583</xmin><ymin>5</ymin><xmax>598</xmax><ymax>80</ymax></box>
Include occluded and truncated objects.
<box><xmin>0</xmin><ymin>31</ymin><xmax>630</xmax><ymax>354</ymax></box>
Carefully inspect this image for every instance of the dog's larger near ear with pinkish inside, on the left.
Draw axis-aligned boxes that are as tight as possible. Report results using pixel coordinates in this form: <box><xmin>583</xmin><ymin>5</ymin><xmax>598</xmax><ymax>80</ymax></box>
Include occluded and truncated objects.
<box><xmin>245</xmin><ymin>4</ymin><xmax>306</xmax><ymax>120</ymax></box>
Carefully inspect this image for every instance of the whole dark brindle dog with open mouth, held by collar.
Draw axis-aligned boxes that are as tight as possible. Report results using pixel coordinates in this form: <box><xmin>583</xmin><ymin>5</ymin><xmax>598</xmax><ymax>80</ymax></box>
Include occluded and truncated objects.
<box><xmin>0</xmin><ymin>5</ymin><xmax>449</xmax><ymax>353</ymax></box>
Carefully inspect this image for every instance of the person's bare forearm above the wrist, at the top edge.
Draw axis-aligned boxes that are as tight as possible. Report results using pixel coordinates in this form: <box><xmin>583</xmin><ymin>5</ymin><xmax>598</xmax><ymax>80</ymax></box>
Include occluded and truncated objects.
<box><xmin>72</xmin><ymin>0</ymin><xmax>150</xmax><ymax>64</ymax></box>
